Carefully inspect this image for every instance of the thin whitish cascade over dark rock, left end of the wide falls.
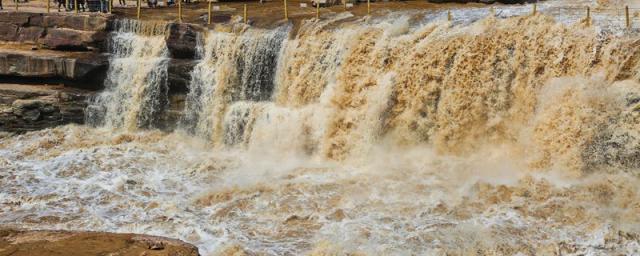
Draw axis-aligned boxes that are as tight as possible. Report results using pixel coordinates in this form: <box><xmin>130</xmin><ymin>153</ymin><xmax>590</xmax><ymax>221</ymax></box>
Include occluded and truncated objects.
<box><xmin>182</xmin><ymin>27</ymin><xmax>289</xmax><ymax>143</ymax></box>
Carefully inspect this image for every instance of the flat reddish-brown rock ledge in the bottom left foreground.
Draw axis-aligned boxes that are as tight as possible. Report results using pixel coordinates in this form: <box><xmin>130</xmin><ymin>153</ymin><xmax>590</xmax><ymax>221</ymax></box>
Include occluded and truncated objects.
<box><xmin>0</xmin><ymin>229</ymin><xmax>199</xmax><ymax>256</ymax></box>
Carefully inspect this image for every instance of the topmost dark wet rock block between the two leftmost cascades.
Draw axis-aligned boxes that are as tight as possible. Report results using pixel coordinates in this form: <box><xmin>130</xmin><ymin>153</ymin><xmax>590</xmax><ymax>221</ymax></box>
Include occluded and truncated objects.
<box><xmin>167</xmin><ymin>23</ymin><xmax>202</xmax><ymax>59</ymax></box>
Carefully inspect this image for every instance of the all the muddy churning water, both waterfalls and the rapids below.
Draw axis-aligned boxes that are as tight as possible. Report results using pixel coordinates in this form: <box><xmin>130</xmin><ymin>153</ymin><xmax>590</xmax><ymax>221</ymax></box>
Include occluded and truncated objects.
<box><xmin>0</xmin><ymin>2</ymin><xmax>640</xmax><ymax>255</ymax></box>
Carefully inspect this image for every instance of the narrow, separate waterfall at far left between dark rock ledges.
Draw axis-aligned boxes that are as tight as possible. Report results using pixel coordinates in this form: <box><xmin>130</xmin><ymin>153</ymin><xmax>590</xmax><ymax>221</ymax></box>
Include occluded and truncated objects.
<box><xmin>86</xmin><ymin>20</ymin><xmax>169</xmax><ymax>130</ymax></box>
